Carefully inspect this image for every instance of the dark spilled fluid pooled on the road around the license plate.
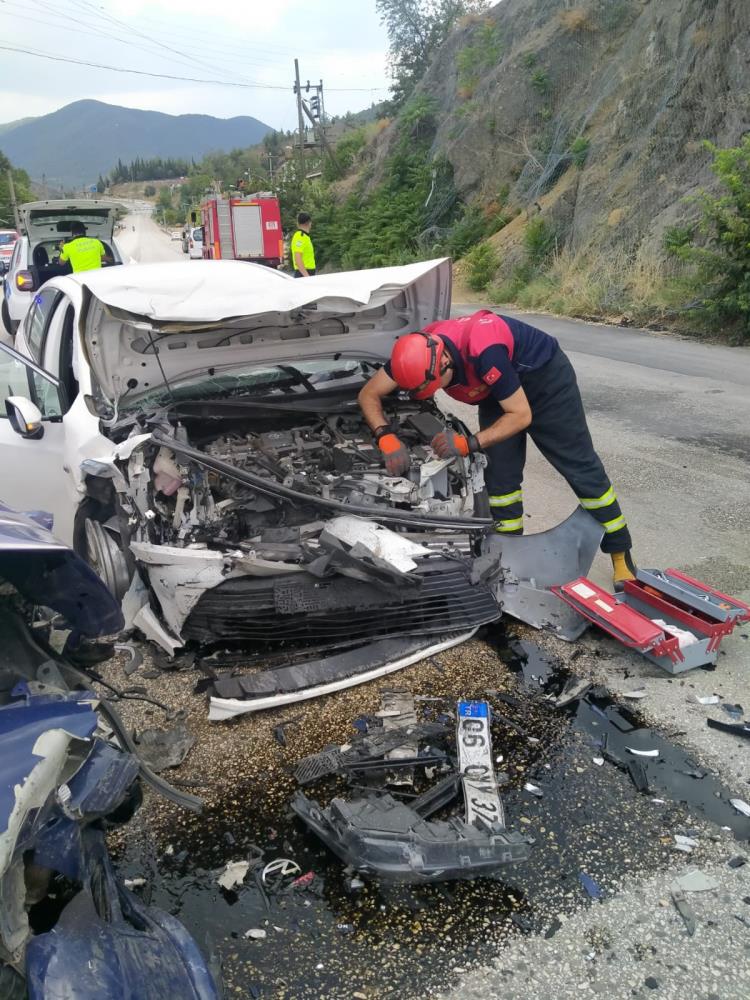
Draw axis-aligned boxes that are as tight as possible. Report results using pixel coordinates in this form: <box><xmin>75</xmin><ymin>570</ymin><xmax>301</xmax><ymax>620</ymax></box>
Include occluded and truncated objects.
<box><xmin>117</xmin><ymin>627</ymin><xmax>750</xmax><ymax>1000</ymax></box>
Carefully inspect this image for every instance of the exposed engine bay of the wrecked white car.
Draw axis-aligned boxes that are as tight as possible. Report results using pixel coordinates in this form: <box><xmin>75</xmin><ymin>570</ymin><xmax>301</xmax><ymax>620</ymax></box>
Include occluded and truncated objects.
<box><xmin>124</xmin><ymin>409</ymin><xmax>484</xmax><ymax>547</ymax></box>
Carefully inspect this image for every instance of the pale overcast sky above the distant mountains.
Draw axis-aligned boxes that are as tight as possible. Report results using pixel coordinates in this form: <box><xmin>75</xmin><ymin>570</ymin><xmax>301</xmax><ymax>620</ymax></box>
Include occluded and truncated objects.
<box><xmin>0</xmin><ymin>0</ymin><xmax>388</xmax><ymax>129</ymax></box>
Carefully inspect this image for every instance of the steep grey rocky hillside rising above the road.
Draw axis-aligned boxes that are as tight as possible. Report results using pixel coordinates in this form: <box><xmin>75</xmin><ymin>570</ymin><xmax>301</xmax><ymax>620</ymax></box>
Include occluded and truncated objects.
<box><xmin>332</xmin><ymin>0</ymin><xmax>750</xmax><ymax>322</ymax></box>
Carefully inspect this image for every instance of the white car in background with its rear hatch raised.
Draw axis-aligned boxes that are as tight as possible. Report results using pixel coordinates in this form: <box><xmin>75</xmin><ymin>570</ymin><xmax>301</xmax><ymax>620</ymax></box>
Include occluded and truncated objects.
<box><xmin>0</xmin><ymin>199</ymin><xmax>122</xmax><ymax>334</ymax></box>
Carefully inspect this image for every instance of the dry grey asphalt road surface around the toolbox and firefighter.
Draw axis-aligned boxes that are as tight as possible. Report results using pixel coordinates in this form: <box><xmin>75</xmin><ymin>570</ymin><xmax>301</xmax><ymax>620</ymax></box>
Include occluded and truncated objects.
<box><xmin>446</xmin><ymin>306</ymin><xmax>750</xmax><ymax>1000</ymax></box>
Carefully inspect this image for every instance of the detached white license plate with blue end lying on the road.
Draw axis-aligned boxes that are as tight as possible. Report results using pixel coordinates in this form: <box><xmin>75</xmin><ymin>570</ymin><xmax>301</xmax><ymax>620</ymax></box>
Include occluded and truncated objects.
<box><xmin>456</xmin><ymin>701</ymin><xmax>505</xmax><ymax>829</ymax></box>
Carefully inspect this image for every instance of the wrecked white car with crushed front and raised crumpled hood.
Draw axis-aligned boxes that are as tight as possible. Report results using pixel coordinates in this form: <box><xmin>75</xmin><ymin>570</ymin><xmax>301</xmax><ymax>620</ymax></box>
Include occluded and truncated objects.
<box><xmin>0</xmin><ymin>260</ymin><xmax>508</xmax><ymax>714</ymax></box>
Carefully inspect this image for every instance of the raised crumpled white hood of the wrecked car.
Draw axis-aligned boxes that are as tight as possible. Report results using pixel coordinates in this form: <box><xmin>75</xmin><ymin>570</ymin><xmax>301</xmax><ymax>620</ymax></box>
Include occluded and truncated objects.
<box><xmin>79</xmin><ymin>258</ymin><xmax>451</xmax><ymax>404</ymax></box>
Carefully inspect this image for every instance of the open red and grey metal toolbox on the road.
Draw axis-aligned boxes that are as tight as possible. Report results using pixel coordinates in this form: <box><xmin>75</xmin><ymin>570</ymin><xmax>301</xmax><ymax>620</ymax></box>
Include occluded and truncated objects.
<box><xmin>551</xmin><ymin>569</ymin><xmax>750</xmax><ymax>674</ymax></box>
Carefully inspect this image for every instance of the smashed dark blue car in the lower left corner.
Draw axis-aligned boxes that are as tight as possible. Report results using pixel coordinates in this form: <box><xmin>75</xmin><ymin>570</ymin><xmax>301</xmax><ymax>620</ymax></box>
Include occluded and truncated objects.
<box><xmin>0</xmin><ymin>505</ymin><xmax>220</xmax><ymax>1000</ymax></box>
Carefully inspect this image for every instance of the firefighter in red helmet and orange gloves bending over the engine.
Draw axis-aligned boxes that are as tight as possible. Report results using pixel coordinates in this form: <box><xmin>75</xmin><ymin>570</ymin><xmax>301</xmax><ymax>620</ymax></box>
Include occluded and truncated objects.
<box><xmin>359</xmin><ymin>310</ymin><xmax>635</xmax><ymax>590</ymax></box>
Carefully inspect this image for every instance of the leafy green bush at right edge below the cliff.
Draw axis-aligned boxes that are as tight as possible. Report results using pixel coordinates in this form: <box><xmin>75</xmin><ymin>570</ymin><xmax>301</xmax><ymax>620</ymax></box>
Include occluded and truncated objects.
<box><xmin>673</xmin><ymin>135</ymin><xmax>750</xmax><ymax>339</ymax></box>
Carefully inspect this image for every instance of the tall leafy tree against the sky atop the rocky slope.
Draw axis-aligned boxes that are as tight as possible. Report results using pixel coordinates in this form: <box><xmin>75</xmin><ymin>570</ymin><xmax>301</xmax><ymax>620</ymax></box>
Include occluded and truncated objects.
<box><xmin>375</xmin><ymin>0</ymin><xmax>489</xmax><ymax>105</ymax></box>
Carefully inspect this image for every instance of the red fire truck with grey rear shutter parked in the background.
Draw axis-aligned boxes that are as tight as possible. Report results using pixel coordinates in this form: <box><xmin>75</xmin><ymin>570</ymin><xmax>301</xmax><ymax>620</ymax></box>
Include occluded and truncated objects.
<box><xmin>201</xmin><ymin>191</ymin><xmax>284</xmax><ymax>267</ymax></box>
